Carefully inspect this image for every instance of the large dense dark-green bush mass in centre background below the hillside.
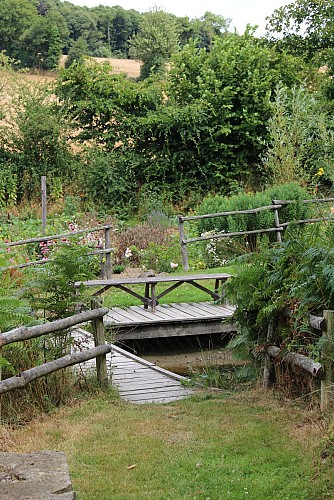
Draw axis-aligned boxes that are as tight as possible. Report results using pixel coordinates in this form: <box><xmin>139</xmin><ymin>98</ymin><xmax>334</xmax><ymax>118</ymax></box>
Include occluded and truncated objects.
<box><xmin>56</xmin><ymin>31</ymin><xmax>308</xmax><ymax>205</ymax></box>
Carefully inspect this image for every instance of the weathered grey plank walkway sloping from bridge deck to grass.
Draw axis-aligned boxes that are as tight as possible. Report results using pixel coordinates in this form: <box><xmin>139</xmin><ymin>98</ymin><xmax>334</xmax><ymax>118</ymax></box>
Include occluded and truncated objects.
<box><xmin>72</xmin><ymin>328</ymin><xmax>194</xmax><ymax>404</ymax></box>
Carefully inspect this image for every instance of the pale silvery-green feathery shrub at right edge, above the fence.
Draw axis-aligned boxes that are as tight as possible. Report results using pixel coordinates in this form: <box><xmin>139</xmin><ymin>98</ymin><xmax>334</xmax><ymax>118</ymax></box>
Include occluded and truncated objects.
<box><xmin>263</xmin><ymin>86</ymin><xmax>334</xmax><ymax>189</ymax></box>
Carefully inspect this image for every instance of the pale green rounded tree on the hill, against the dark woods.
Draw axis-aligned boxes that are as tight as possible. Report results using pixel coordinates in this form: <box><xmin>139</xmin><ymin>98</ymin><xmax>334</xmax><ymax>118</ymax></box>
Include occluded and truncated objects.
<box><xmin>130</xmin><ymin>9</ymin><xmax>178</xmax><ymax>79</ymax></box>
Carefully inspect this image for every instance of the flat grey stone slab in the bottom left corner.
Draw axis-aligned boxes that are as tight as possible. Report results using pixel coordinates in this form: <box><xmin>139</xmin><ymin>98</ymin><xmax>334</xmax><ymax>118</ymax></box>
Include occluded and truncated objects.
<box><xmin>0</xmin><ymin>451</ymin><xmax>76</xmax><ymax>500</ymax></box>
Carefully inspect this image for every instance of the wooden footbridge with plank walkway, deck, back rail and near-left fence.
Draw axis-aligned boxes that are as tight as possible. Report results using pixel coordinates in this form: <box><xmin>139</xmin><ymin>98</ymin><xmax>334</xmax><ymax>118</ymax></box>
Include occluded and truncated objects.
<box><xmin>0</xmin><ymin>273</ymin><xmax>235</xmax><ymax>404</ymax></box>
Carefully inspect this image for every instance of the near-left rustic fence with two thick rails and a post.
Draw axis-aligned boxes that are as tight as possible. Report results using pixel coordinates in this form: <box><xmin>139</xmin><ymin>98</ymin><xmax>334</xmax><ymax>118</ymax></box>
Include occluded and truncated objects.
<box><xmin>0</xmin><ymin>303</ymin><xmax>111</xmax><ymax>395</ymax></box>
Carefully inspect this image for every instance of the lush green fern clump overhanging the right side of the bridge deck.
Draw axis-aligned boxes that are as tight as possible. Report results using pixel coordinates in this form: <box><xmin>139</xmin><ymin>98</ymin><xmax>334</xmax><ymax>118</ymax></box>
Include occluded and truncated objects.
<box><xmin>226</xmin><ymin>224</ymin><xmax>334</xmax><ymax>358</ymax></box>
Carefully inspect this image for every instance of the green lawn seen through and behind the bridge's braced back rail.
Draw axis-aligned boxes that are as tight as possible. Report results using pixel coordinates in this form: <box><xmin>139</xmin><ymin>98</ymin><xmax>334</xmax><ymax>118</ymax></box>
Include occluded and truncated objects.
<box><xmin>102</xmin><ymin>267</ymin><xmax>234</xmax><ymax>307</ymax></box>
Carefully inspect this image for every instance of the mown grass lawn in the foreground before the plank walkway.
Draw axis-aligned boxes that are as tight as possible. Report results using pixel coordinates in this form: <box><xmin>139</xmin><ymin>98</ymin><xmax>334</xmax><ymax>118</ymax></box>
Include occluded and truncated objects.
<box><xmin>0</xmin><ymin>389</ymin><xmax>334</xmax><ymax>500</ymax></box>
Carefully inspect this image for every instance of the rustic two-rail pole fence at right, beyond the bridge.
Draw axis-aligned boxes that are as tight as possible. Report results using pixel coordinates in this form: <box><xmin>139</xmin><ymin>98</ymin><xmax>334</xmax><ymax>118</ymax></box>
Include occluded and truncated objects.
<box><xmin>178</xmin><ymin>198</ymin><xmax>334</xmax><ymax>271</ymax></box>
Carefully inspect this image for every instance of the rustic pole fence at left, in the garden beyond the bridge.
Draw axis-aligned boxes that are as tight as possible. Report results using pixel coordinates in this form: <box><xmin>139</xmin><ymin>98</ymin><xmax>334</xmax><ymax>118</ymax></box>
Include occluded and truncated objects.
<box><xmin>0</xmin><ymin>224</ymin><xmax>114</xmax><ymax>279</ymax></box>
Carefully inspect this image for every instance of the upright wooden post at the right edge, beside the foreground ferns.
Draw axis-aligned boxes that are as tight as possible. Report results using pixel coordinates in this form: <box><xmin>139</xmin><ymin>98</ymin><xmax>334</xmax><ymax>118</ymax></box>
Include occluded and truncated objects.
<box><xmin>320</xmin><ymin>311</ymin><xmax>334</xmax><ymax>412</ymax></box>
